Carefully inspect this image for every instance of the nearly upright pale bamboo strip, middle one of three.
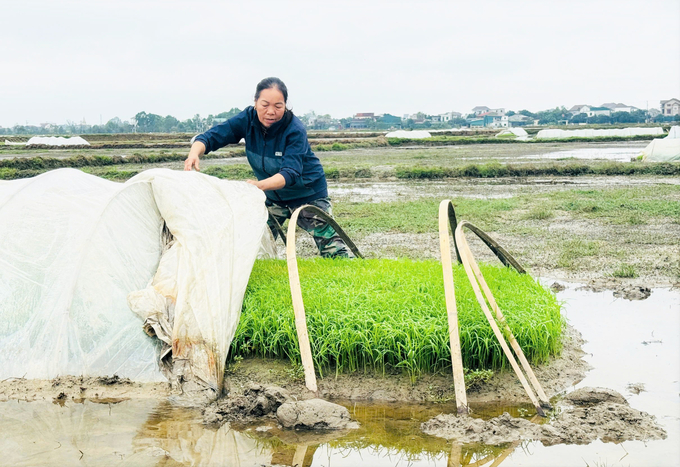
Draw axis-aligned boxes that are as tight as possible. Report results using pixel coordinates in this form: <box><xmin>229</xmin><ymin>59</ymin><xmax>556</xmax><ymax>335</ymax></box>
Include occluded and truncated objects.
<box><xmin>439</xmin><ymin>199</ymin><xmax>469</xmax><ymax>414</ymax></box>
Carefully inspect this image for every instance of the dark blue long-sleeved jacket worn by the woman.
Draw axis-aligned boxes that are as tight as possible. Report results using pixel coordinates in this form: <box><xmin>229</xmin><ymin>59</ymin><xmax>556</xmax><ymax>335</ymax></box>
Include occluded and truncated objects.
<box><xmin>196</xmin><ymin>106</ymin><xmax>328</xmax><ymax>206</ymax></box>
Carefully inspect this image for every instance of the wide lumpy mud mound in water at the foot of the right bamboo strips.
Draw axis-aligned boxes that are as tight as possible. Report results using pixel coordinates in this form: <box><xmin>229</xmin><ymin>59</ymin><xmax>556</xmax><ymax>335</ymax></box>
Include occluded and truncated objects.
<box><xmin>421</xmin><ymin>388</ymin><xmax>666</xmax><ymax>445</ymax></box>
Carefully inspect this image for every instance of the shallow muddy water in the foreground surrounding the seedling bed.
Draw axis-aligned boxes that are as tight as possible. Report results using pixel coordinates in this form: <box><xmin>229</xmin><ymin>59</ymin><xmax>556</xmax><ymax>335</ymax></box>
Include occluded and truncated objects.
<box><xmin>0</xmin><ymin>288</ymin><xmax>680</xmax><ymax>467</ymax></box>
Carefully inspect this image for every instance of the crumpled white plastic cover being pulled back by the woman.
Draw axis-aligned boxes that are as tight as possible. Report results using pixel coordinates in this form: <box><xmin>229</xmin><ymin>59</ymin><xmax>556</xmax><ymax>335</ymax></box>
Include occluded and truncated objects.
<box><xmin>0</xmin><ymin>169</ymin><xmax>271</xmax><ymax>390</ymax></box>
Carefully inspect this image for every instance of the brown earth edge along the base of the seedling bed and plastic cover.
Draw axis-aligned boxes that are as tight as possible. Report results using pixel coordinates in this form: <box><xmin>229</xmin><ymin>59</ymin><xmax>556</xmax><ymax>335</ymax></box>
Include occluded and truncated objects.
<box><xmin>0</xmin><ymin>327</ymin><xmax>589</xmax><ymax>407</ymax></box>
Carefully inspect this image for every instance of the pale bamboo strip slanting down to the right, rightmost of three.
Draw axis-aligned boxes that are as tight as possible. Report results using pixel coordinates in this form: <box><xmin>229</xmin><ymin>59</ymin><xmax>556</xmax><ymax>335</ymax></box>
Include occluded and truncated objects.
<box><xmin>455</xmin><ymin>221</ymin><xmax>545</xmax><ymax>417</ymax></box>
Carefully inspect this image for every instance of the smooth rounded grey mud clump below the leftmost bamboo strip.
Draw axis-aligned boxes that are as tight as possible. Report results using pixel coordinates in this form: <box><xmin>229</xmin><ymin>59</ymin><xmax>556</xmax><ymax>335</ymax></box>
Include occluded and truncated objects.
<box><xmin>276</xmin><ymin>399</ymin><xmax>358</xmax><ymax>430</ymax></box>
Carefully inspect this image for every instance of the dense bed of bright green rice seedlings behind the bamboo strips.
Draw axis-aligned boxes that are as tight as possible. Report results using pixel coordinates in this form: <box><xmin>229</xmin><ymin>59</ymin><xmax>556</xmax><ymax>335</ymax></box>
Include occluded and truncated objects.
<box><xmin>231</xmin><ymin>258</ymin><xmax>564</xmax><ymax>378</ymax></box>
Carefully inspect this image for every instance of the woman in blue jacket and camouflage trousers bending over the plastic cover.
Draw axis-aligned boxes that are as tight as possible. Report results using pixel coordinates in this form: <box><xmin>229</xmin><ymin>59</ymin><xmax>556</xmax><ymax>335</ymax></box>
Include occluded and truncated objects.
<box><xmin>184</xmin><ymin>78</ymin><xmax>351</xmax><ymax>257</ymax></box>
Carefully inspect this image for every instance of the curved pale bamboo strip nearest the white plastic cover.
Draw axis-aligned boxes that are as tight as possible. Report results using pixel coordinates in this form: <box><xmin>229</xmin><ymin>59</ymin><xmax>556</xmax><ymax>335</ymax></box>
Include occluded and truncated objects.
<box><xmin>286</xmin><ymin>206</ymin><xmax>317</xmax><ymax>392</ymax></box>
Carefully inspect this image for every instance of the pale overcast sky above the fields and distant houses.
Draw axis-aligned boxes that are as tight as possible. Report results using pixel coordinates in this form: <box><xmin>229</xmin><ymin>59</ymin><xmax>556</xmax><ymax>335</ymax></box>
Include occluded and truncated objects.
<box><xmin>0</xmin><ymin>0</ymin><xmax>680</xmax><ymax>127</ymax></box>
